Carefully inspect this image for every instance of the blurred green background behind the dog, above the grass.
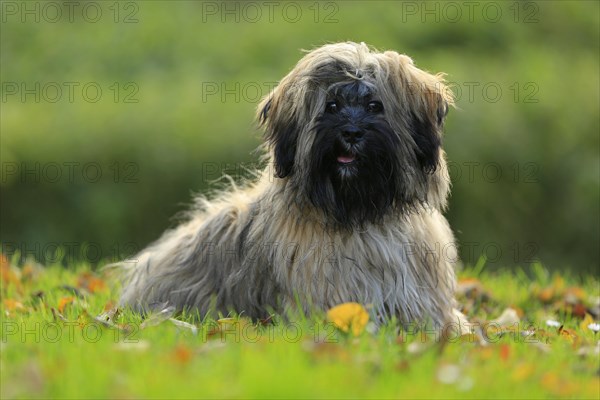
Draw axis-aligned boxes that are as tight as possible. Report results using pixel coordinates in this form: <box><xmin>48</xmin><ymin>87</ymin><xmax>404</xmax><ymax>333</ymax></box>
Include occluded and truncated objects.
<box><xmin>0</xmin><ymin>1</ymin><xmax>600</xmax><ymax>272</ymax></box>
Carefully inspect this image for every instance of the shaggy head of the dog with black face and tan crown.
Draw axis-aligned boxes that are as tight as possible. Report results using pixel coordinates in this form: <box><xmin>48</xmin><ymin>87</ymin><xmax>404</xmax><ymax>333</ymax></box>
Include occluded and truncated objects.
<box><xmin>259</xmin><ymin>43</ymin><xmax>453</xmax><ymax>226</ymax></box>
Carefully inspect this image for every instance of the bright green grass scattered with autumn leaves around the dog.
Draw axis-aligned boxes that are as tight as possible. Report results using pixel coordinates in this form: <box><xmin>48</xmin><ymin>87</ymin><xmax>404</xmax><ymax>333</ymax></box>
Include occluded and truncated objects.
<box><xmin>0</xmin><ymin>255</ymin><xmax>600</xmax><ymax>399</ymax></box>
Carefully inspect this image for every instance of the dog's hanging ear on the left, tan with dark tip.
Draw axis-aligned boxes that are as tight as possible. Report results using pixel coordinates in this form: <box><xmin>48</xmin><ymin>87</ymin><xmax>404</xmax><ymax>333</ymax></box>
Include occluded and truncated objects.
<box><xmin>258</xmin><ymin>91</ymin><xmax>298</xmax><ymax>178</ymax></box>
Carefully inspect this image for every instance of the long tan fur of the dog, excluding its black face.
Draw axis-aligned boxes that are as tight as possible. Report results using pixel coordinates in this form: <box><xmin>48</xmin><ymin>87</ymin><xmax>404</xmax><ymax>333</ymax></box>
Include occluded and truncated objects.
<box><xmin>121</xmin><ymin>43</ymin><xmax>456</xmax><ymax>326</ymax></box>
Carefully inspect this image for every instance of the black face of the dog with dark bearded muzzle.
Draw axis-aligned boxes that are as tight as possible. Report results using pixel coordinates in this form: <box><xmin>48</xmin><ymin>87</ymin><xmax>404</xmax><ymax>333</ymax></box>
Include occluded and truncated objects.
<box><xmin>307</xmin><ymin>81</ymin><xmax>401</xmax><ymax>223</ymax></box>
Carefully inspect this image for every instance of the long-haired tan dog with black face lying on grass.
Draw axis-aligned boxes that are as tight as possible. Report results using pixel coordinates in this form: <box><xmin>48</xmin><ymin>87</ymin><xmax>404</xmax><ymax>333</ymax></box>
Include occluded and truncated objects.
<box><xmin>120</xmin><ymin>42</ymin><xmax>457</xmax><ymax>327</ymax></box>
